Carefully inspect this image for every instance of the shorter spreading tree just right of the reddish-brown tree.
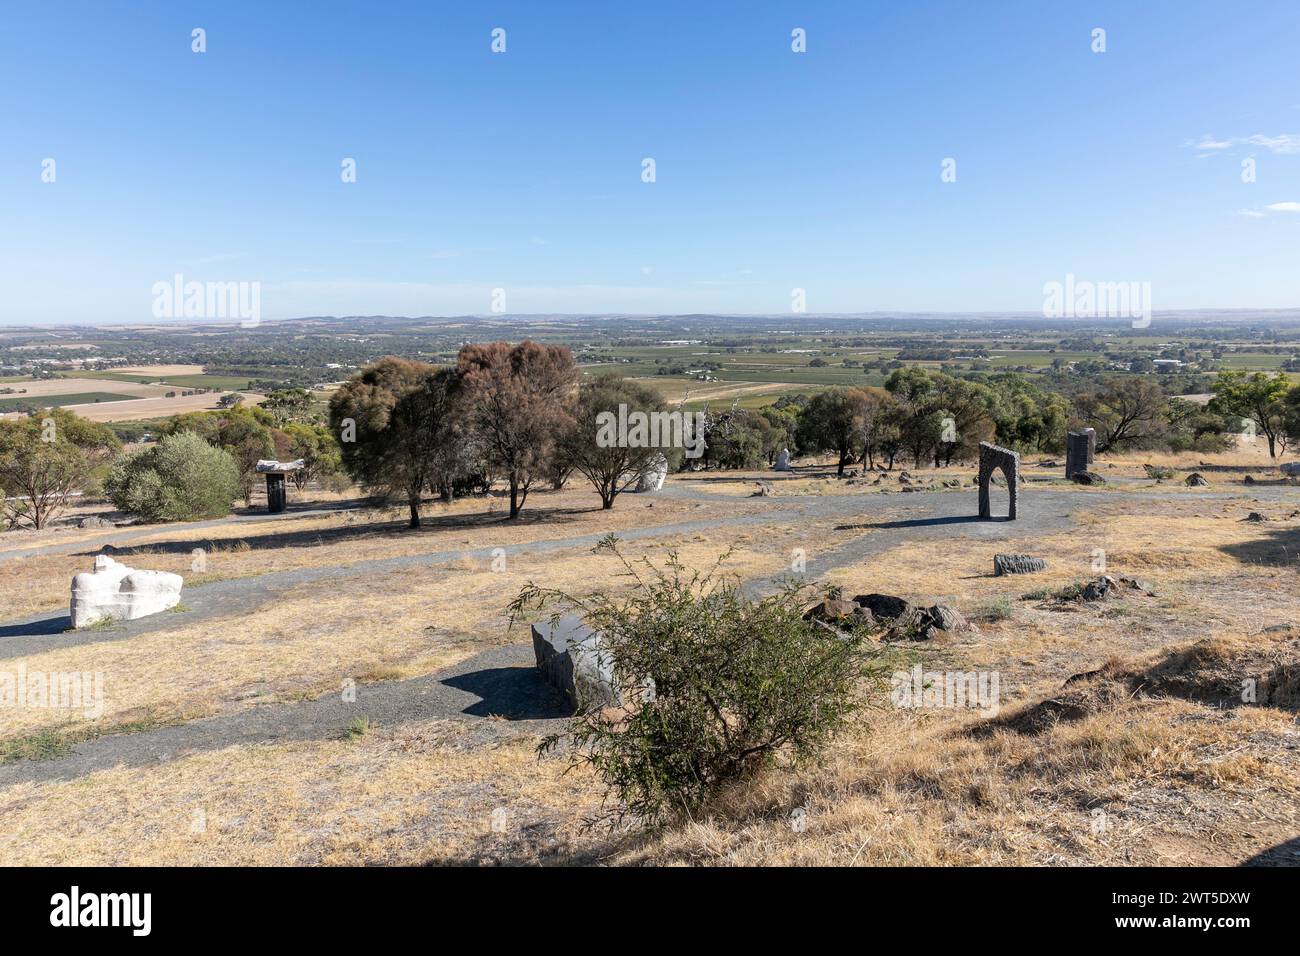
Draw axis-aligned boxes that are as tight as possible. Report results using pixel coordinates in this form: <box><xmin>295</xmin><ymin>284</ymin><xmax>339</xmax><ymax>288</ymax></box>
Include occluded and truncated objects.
<box><xmin>558</xmin><ymin>375</ymin><xmax>684</xmax><ymax>509</ymax></box>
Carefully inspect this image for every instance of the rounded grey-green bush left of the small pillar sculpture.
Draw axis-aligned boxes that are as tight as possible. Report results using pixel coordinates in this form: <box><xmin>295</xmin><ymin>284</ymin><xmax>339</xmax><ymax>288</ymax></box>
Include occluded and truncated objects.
<box><xmin>104</xmin><ymin>432</ymin><xmax>241</xmax><ymax>522</ymax></box>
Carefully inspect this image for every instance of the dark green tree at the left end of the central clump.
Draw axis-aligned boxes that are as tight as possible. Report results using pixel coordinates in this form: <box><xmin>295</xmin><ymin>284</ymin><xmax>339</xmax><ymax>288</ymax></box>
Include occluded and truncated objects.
<box><xmin>329</xmin><ymin>355</ymin><xmax>456</xmax><ymax>528</ymax></box>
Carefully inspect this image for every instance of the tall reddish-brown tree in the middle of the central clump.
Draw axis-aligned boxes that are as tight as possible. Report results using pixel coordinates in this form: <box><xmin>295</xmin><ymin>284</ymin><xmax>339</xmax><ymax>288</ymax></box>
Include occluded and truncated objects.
<box><xmin>456</xmin><ymin>342</ymin><xmax>577</xmax><ymax>519</ymax></box>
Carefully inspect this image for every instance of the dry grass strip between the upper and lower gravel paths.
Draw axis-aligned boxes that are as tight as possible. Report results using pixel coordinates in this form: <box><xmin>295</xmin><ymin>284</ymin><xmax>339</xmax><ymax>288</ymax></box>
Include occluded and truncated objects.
<box><xmin>0</xmin><ymin>536</ymin><xmax>785</xmax><ymax>739</ymax></box>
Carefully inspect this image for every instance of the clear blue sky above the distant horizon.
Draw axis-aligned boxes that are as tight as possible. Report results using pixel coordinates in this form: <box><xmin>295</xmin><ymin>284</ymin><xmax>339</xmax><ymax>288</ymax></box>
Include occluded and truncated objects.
<box><xmin>0</xmin><ymin>0</ymin><xmax>1300</xmax><ymax>324</ymax></box>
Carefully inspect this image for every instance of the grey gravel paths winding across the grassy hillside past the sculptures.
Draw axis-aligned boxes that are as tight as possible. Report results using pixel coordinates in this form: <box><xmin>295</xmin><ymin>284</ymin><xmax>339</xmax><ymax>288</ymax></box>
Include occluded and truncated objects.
<box><xmin>0</xmin><ymin>483</ymin><xmax>1297</xmax><ymax>786</ymax></box>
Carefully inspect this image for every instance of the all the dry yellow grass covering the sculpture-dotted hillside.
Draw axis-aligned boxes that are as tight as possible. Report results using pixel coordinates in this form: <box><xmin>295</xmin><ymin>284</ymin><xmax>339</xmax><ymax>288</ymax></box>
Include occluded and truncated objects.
<box><xmin>0</xmin><ymin>460</ymin><xmax>1300</xmax><ymax>865</ymax></box>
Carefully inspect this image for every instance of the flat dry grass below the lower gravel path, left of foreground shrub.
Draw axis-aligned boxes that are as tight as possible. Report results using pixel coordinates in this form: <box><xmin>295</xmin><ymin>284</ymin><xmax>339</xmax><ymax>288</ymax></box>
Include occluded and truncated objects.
<box><xmin>0</xmin><ymin>721</ymin><xmax>597</xmax><ymax>866</ymax></box>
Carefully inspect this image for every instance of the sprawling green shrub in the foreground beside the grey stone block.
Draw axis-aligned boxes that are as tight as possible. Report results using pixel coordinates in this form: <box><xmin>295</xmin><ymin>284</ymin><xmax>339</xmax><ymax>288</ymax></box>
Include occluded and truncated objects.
<box><xmin>511</xmin><ymin>536</ymin><xmax>868</xmax><ymax>825</ymax></box>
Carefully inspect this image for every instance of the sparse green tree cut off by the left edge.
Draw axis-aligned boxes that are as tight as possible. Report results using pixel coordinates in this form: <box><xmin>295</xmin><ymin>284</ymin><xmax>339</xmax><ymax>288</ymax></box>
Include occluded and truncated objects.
<box><xmin>0</xmin><ymin>408</ymin><xmax>121</xmax><ymax>531</ymax></box>
